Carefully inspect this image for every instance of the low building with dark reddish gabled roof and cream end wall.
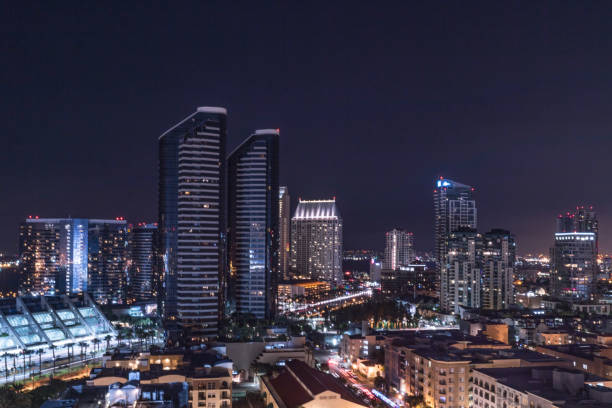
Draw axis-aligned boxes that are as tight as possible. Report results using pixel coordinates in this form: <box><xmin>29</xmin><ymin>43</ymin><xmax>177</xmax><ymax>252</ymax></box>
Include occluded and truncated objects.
<box><xmin>261</xmin><ymin>361</ymin><xmax>366</xmax><ymax>408</ymax></box>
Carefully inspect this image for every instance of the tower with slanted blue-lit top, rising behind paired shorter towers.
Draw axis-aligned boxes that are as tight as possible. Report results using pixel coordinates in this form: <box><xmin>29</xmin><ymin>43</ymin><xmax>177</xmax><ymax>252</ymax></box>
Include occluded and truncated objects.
<box><xmin>434</xmin><ymin>177</ymin><xmax>477</xmax><ymax>265</ymax></box>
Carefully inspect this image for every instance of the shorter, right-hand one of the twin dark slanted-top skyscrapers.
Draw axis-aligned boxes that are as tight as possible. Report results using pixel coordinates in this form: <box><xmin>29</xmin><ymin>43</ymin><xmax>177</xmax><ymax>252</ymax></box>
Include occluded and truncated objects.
<box><xmin>228</xmin><ymin>129</ymin><xmax>279</xmax><ymax>319</ymax></box>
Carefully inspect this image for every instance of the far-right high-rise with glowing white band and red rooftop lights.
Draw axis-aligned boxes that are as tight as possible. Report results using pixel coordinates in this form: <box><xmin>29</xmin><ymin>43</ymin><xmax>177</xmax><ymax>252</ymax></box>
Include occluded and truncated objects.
<box><xmin>550</xmin><ymin>207</ymin><xmax>599</xmax><ymax>299</ymax></box>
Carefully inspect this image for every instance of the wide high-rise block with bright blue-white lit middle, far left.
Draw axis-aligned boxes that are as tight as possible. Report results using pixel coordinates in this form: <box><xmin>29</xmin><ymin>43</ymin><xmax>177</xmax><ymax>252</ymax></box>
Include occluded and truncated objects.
<box><xmin>20</xmin><ymin>217</ymin><xmax>128</xmax><ymax>303</ymax></box>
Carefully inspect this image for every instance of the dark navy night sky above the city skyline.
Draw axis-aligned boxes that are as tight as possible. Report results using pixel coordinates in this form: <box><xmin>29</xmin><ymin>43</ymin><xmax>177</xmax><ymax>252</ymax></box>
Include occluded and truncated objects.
<box><xmin>0</xmin><ymin>1</ymin><xmax>612</xmax><ymax>253</ymax></box>
